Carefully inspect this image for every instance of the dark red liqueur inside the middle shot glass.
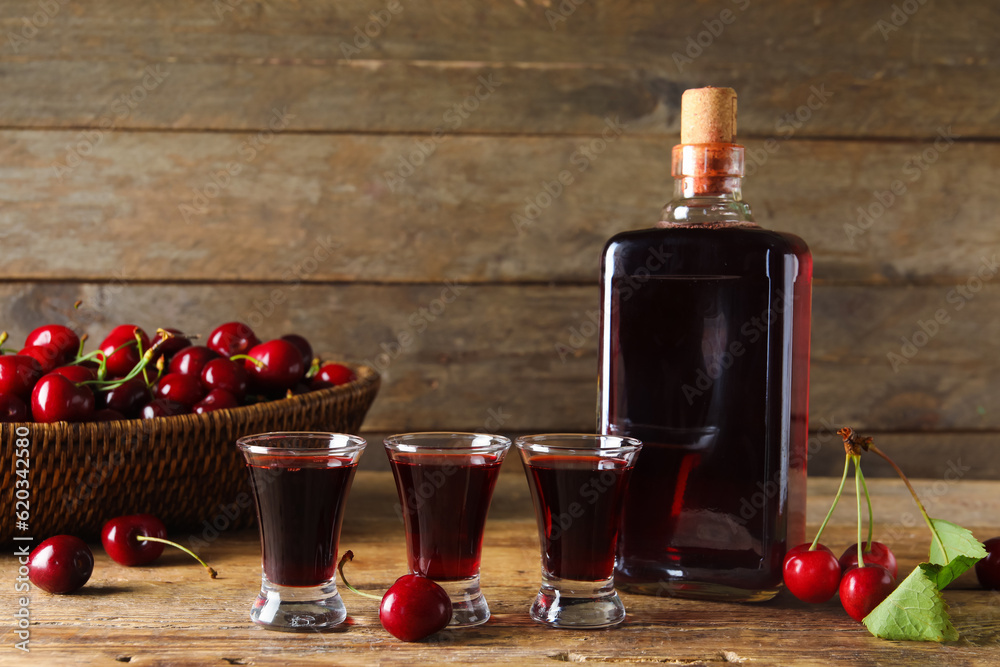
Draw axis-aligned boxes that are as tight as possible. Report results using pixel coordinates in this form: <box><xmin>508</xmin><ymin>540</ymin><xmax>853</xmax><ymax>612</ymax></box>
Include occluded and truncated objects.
<box><xmin>391</xmin><ymin>454</ymin><xmax>502</xmax><ymax>581</ymax></box>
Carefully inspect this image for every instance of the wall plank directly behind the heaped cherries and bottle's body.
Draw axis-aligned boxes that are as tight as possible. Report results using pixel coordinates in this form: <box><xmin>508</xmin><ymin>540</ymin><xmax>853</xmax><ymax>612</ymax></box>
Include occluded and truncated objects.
<box><xmin>0</xmin><ymin>282</ymin><xmax>1000</xmax><ymax>438</ymax></box>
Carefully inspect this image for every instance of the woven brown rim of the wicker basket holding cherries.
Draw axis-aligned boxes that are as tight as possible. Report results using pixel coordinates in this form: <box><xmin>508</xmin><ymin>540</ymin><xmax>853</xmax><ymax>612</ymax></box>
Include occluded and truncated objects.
<box><xmin>3</xmin><ymin>360</ymin><xmax>381</xmax><ymax>431</ymax></box>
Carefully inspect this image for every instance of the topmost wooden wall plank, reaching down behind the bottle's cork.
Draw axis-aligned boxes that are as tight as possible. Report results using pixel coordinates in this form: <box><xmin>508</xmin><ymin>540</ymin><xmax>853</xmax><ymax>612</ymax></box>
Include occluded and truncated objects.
<box><xmin>0</xmin><ymin>0</ymin><xmax>1000</xmax><ymax>137</ymax></box>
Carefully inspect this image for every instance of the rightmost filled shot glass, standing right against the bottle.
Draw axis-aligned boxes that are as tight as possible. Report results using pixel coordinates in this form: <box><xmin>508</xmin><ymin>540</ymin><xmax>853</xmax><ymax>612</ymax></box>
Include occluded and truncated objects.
<box><xmin>516</xmin><ymin>434</ymin><xmax>642</xmax><ymax>628</ymax></box>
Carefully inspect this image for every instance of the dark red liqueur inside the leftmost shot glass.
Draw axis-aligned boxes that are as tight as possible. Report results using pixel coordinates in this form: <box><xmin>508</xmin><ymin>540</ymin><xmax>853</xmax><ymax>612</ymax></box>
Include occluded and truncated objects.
<box><xmin>247</xmin><ymin>457</ymin><xmax>357</xmax><ymax>586</ymax></box>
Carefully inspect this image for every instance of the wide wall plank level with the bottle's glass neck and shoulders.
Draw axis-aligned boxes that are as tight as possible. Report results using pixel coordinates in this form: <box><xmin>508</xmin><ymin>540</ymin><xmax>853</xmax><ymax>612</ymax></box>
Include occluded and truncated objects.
<box><xmin>0</xmin><ymin>130</ymin><xmax>1000</xmax><ymax>284</ymax></box>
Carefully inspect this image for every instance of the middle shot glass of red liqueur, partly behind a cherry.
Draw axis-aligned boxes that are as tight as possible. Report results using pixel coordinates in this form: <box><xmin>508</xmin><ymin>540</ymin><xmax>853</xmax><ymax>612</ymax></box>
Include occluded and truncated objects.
<box><xmin>385</xmin><ymin>433</ymin><xmax>510</xmax><ymax>627</ymax></box>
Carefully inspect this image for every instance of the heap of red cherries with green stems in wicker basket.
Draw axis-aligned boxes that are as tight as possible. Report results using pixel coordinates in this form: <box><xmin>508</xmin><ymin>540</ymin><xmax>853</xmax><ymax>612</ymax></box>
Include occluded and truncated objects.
<box><xmin>0</xmin><ymin>322</ymin><xmax>354</xmax><ymax>422</ymax></box>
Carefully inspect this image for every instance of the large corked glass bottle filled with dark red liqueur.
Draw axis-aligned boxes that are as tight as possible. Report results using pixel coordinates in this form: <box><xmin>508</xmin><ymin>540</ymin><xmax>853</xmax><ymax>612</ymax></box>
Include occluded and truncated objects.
<box><xmin>599</xmin><ymin>88</ymin><xmax>812</xmax><ymax>601</ymax></box>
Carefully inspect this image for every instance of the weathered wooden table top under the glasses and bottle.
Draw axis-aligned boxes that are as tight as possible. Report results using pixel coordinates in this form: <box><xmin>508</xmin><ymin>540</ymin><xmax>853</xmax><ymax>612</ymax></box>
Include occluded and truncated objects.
<box><xmin>0</xmin><ymin>469</ymin><xmax>1000</xmax><ymax>665</ymax></box>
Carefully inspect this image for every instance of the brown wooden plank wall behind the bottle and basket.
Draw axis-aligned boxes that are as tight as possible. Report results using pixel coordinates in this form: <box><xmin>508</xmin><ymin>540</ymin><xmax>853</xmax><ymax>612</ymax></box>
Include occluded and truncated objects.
<box><xmin>0</xmin><ymin>0</ymin><xmax>1000</xmax><ymax>478</ymax></box>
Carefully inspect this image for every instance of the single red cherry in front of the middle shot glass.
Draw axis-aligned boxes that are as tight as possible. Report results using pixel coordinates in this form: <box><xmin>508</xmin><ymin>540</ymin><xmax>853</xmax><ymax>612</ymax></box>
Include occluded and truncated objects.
<box><xmin>378</xmin><ymin>574</ymin><xmax>451</xmax><ymax>642</ymax></box>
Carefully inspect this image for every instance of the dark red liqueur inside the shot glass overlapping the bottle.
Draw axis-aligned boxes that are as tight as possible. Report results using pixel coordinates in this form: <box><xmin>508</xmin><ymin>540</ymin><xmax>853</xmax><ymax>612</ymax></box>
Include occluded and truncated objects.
<box><xmin>526</xmin><ymin>456</ymin><xmax>631</xmax><ymax>581</ymax></box>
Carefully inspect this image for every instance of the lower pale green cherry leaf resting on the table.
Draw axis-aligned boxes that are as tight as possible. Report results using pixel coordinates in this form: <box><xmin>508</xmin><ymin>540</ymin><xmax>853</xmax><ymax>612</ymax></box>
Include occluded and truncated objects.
<box><xmin>864</xmin><ymin>563</ymin><xmax>958</xmax><ymax>642</ymax></box>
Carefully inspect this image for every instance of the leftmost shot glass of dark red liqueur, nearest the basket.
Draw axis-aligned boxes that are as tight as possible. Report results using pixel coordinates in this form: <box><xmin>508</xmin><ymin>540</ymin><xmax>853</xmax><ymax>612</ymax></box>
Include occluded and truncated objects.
<box><xmin>237</xmin><ymin>432</ymin><xmax>366</xmax><ymax>632</ymax></box>
